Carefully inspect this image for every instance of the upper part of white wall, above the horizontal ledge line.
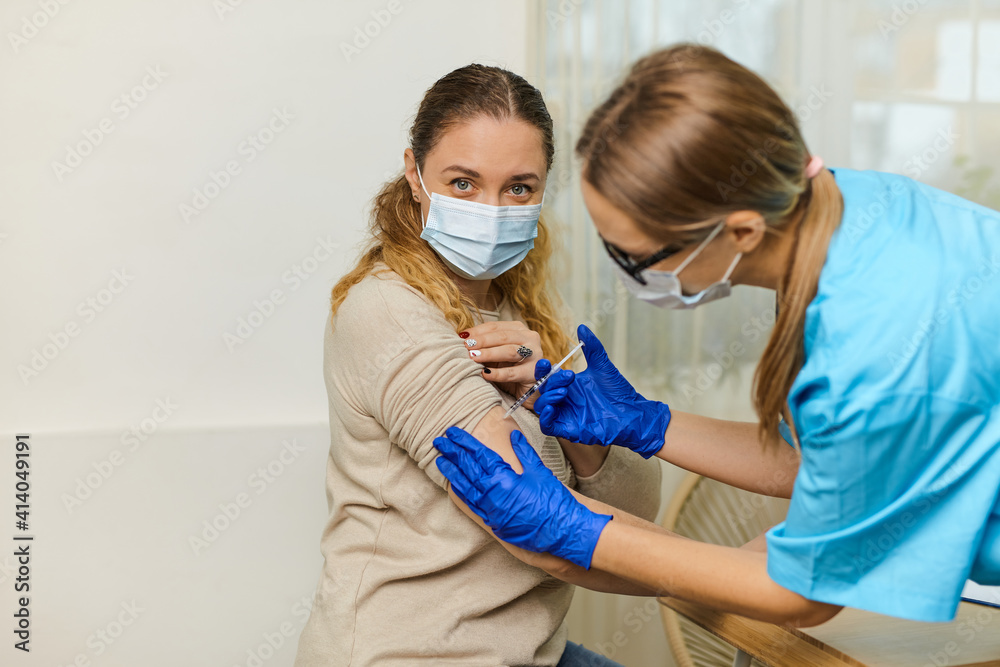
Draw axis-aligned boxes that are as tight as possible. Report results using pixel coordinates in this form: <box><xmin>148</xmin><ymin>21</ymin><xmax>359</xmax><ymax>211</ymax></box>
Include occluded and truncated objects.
<box><xmin>0</xmin><ymin>0</ymin><xmax>526</xmax><ymax>431</ymax></box>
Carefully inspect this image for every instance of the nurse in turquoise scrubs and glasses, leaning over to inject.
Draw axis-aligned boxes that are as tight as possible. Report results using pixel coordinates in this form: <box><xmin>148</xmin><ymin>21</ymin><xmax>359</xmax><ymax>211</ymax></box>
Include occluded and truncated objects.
<box><xmin>435</xmin><ymin>45</ymin><xmax>1000</xmax><ymax>626</ymax></box>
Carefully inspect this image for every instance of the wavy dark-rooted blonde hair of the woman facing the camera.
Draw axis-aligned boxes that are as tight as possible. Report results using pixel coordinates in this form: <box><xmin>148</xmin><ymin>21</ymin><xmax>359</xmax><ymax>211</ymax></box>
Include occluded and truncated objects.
<box><xmin>331</xmin><ymin>65</ymin><xmax>570</xmax><ymax>366</ymax></box>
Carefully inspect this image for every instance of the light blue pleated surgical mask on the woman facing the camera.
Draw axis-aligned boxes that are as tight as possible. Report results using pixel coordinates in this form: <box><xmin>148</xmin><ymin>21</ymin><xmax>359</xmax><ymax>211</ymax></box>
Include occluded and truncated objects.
<box><xmin>417</xmin><ymin>167</ymin><xmax>545</xmax><ymax>280</ymax></box>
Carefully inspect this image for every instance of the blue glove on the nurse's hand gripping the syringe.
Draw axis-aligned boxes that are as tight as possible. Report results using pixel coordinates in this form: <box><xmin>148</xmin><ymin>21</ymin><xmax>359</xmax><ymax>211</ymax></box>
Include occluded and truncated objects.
<box><xmin>534</xmin><ymin>324</ymin><xmax>670</xmax><ymax>459</ymax></box>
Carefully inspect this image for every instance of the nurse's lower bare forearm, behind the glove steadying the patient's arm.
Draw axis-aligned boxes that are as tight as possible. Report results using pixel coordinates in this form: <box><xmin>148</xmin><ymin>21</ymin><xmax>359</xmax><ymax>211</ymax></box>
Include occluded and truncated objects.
<box><xmin>591</xmin><ymin>521</ymin><xmax>840</xmax><ymax>627</ymax></box>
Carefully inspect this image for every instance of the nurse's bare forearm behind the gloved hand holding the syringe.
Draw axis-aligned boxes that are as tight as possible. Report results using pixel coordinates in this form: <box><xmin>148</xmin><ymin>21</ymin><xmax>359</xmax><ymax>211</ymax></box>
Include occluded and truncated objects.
<box><xmin>657</xmin><ymin>412</ymin><xmax>799</xmax><ymax>498</ymax></box>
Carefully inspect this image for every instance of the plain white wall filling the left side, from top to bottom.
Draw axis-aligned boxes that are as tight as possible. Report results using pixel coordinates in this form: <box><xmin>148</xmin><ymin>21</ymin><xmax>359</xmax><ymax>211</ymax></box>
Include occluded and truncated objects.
<box><xmin>0</xmin><ymin>0</ymin><xmax>527</xmax><ymax>667</ymax></box>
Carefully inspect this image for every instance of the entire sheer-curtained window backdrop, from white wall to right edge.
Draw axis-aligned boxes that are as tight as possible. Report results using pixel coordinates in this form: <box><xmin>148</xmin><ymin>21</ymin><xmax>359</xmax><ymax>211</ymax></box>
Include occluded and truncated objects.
<box><xmin>528</xmin><ymin>0</ymin><xmax>1000</xmax><ymax>667</ymax></box>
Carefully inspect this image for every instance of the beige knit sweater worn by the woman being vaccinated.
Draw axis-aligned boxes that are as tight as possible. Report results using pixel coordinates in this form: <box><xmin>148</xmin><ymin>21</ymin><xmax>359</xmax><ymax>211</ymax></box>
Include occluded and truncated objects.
<box><xmin>295</xmin><ymin>273</ymin><xmax>660</xmax><ymax>667</ymax></box>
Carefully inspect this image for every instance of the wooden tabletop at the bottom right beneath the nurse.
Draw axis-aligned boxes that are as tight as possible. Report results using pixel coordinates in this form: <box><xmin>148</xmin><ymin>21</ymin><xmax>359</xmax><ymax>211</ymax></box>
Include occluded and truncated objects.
<box><xmin>660</xmin><ymin>598</ymin><xmax>1000</xmax><ymax>667</ymax></box>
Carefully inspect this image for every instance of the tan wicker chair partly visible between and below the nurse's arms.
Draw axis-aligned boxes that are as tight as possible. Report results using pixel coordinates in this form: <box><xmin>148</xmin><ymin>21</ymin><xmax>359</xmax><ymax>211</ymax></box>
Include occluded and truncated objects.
<box><xmin>660</xmin><ymin>473</ymin><xmax>788</xmax><ymax>667</ymax></box>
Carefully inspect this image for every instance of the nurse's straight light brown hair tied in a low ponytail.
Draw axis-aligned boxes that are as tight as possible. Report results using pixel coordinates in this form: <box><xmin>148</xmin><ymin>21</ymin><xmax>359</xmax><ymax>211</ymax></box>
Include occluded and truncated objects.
<box><xmin>576</xmin><ymin>44</ymin><xmax>843</xmax><ymax>442</ymax></box>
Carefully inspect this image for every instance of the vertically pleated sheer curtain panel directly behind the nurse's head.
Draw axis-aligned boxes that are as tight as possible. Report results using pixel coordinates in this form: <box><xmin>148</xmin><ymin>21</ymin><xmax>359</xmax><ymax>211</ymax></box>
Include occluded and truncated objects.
<box><xmin>536</xmin><ymin>0</ymin><xmax>798</xmax><ymax>428</ymax></box>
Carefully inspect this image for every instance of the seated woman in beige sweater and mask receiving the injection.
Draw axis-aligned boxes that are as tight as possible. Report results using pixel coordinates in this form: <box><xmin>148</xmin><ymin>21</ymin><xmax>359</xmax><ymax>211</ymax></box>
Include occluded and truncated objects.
<box><xmin>295</xmin><ymin>65</ymin><xmax>660</xmax><ymax>667</ymax></box>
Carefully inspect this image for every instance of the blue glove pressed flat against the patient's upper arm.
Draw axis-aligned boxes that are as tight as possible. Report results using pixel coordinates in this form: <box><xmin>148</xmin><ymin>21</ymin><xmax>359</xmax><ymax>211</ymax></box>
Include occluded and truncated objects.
<box><xmin>434</xmin><ymin>426</ymin><xmax>611</xmax><ymax>569</ymax></box>
